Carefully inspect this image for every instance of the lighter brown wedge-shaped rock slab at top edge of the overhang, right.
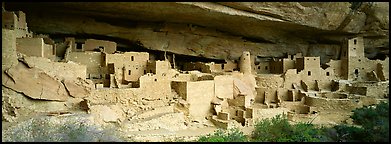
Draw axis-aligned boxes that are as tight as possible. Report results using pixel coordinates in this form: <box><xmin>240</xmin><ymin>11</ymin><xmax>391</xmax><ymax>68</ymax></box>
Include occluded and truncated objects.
<box><xmin>219</xmin><ymin>2</ymin><xmax>350</xmax><ymax>30</ymax></box>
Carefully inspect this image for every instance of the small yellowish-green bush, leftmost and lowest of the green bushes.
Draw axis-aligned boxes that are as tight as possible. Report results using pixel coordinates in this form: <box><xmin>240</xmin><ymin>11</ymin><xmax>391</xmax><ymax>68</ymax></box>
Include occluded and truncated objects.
<box><xmin>198</xmin><ymin>128</ymin><xmax>247</xmax><ymax>142</ymax></box>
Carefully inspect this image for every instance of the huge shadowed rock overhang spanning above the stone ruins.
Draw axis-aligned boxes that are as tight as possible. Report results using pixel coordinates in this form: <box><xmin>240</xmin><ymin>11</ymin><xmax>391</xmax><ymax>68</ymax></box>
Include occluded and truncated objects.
<box><xmin>5</xmin><ymin>2</ymin><xmax>389</xmax><ymax>61</ymax></box>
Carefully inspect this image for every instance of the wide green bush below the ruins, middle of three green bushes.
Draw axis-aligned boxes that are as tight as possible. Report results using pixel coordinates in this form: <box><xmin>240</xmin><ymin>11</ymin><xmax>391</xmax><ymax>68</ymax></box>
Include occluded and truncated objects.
<box><xmin>252</xmin><ymin>115</ymin><xmax>321</xmax><ymax>142</ymax></box>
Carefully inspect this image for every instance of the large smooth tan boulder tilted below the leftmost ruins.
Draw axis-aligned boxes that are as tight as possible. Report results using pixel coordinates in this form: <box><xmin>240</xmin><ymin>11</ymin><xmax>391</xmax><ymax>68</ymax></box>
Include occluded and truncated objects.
<box><xmin>2</xmin><ymin>63</ymin><xmax>69</xmax><ymax>101</ymax></box>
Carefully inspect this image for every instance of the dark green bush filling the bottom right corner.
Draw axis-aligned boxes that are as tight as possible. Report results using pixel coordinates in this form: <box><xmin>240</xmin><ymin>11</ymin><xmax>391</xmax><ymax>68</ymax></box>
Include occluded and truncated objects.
<box><xmin>324</xmin><ymin>102</ymin><xmax>389</xmax><ymax>142</ymax></box>
